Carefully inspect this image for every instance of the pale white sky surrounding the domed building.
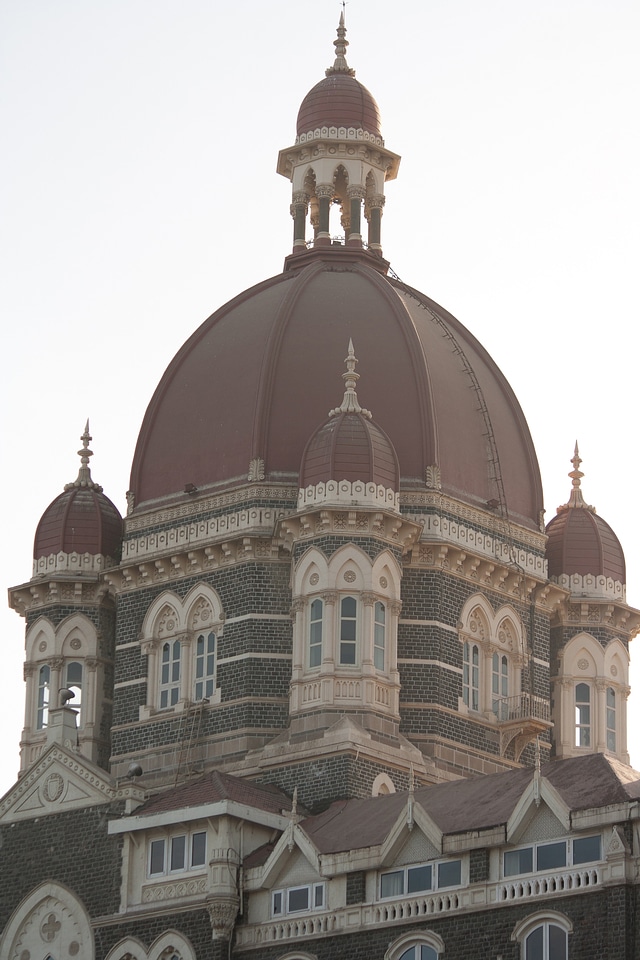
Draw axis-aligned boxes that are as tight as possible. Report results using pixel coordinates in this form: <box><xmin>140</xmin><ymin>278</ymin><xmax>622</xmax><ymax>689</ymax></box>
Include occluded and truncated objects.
<box><xmin>0</xmin><ymin>0</ymin><xmax>640</xmax><ymax>794</ymax></box>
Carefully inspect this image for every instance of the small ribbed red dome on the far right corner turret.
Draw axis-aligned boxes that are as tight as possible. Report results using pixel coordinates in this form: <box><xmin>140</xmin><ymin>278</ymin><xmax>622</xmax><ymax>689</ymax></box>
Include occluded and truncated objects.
<box><xmin>546</xmin><ymin>507</ymin><xmax>626</xmax><ymax>583</ymax></box>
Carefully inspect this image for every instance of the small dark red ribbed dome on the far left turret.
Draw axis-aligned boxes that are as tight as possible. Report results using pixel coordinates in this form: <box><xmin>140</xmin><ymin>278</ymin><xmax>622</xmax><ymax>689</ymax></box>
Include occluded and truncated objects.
<box><xmin>33</xmin><ymin>487</ymin><xmax>122</xmax><ymax>560</ymax></box>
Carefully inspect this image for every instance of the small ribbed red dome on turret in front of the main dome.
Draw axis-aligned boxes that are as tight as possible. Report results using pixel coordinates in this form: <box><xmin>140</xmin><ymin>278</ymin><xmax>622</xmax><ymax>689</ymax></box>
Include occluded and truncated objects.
<box><xmin>300</xmin><ymin>413</ymin><xmax>400</xmax><ymax>491</ymax></box>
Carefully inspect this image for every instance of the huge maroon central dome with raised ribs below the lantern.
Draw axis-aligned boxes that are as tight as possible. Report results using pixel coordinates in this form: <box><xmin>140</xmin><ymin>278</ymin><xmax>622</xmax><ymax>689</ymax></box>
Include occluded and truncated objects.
<box><xmin>131</xmin><ymin>247</ymin><xmax>542</xmax><ymax>530</ymax></box>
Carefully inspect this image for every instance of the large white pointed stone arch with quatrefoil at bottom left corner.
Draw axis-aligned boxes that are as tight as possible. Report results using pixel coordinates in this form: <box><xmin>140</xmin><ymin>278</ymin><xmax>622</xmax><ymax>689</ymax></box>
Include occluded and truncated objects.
<box><xmin>0</xmin><ymin>880</ymin><xmax>95</xmax><ymax>960</ymax></box>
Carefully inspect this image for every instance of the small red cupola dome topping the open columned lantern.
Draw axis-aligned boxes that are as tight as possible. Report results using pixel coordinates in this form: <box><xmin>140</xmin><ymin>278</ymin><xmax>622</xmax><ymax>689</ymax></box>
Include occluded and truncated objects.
<box><xmin>296</xmin><ymin>74</ymin><xmax>381</xmax><ymax>137</ymax></box>
